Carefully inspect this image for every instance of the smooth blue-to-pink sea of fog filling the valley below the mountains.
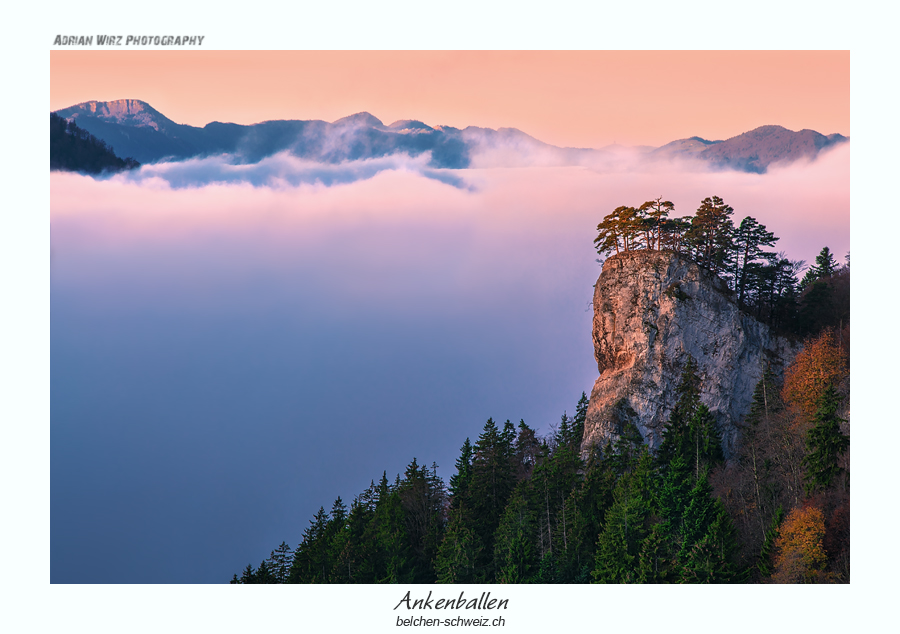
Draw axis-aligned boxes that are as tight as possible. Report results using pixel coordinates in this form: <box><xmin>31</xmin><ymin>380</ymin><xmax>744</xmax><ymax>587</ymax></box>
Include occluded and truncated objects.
<box><xmin>50</xmin><ymin>148</ymin><xmax>849</xmax><ymax>583</ymax></box>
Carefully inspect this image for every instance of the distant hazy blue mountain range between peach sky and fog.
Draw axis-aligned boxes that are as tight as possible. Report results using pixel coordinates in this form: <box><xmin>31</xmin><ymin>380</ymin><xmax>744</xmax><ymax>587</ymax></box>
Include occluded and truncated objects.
<box><xmin>55</xmin><ymin>99</ymin><xmax>849</xmax><ymax>173</ymax></box>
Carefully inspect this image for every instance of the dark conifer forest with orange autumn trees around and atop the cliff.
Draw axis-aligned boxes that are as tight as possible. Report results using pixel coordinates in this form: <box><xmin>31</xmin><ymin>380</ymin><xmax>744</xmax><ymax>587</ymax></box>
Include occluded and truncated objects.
<box><xmin>231</xmin><ymin>197</ymin><xmax>850</xmax><ymax>583</ymax></box>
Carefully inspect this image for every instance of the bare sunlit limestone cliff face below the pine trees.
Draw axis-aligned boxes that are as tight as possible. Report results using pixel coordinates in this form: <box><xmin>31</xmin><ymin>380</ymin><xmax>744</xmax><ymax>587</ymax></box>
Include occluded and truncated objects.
<box><xmin>582</xmin><ymin>251</ymin><xmax>796</xmax><ymax>457</ymax></box>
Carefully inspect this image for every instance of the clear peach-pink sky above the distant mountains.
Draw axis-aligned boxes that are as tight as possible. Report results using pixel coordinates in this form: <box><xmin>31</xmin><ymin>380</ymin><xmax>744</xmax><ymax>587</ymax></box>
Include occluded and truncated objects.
<box><xmin>50</xmin><ymin>51</ymin><xmax>850</xmax><ymax>147</ymax></box>
